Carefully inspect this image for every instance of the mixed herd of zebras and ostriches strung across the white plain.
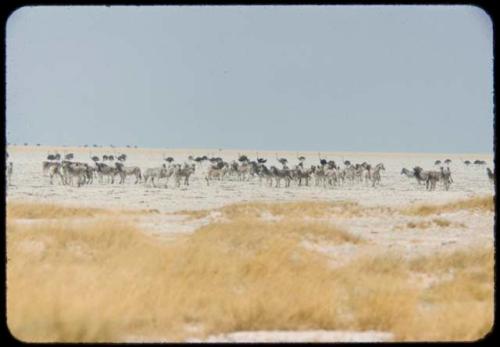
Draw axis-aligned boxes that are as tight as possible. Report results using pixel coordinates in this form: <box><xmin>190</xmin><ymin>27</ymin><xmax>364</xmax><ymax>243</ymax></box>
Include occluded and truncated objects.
<box><xmin>3</xmin><ymin>153</ymin><xmax>495</xmax><ymax>190</ymax></box>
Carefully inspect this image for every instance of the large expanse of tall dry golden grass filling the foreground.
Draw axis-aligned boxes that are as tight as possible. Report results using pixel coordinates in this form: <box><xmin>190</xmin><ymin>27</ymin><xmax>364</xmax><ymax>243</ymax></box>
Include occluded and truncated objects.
<box><xmin>7</xmin><ymin>201</ymin><xmax>493</xmax><ymax>342</ymax></box>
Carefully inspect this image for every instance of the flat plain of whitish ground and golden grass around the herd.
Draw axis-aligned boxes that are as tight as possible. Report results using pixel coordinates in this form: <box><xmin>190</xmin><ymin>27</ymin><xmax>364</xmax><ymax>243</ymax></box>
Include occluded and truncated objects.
<box><xmin>6</xmin><ymin>146</ymin><xmax>495</xmax><ymax>342</ymax></box>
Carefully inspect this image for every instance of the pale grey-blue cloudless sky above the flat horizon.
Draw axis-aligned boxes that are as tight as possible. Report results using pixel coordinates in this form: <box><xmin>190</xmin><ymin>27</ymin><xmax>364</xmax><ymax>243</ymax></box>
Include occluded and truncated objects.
<box><xmin>6</xmin><ymin>5</ymin><xmax>494</xmax><ymax>153</ymax></box>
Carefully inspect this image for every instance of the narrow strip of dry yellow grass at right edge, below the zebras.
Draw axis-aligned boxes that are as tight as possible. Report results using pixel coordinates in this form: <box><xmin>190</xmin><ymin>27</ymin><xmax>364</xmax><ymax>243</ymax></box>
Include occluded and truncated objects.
<box><xmin>402</xmin><ymin>195</ymin><xmax>495</xmax><ymax>216</ymax></box>
